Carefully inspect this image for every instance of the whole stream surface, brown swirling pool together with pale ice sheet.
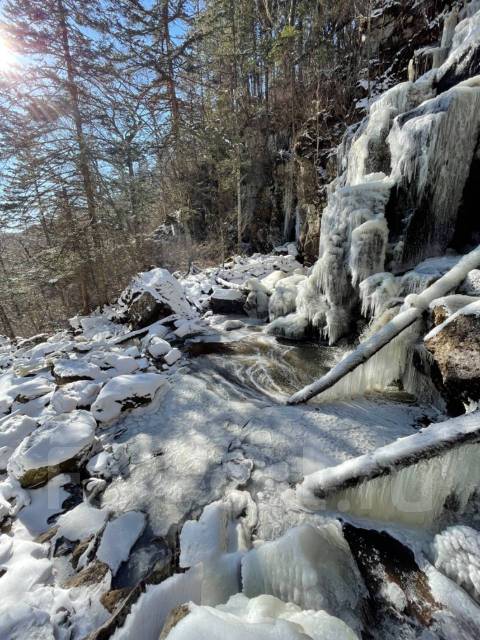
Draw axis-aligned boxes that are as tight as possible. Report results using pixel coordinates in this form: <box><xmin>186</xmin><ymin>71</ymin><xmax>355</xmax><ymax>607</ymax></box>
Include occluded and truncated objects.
<box><xmin>101</xmin><ymin>327</ymin><xmax>435</xmax><ymax>564</ymax></box>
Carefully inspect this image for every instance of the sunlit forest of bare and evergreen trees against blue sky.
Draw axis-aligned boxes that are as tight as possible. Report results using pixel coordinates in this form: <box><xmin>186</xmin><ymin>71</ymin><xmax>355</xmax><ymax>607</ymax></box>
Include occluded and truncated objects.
<box><xmin>0</xmin><ymin>0</ymin><xmax>412</xmax><ymax>336</ymax></box>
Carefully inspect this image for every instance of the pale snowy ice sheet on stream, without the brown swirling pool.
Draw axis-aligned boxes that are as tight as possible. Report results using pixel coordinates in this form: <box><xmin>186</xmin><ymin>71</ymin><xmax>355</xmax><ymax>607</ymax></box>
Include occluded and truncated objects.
<box><xmin>102</xmin><ymin>360</ymin><xmax>436</xmax><ymax>539</ymax></box>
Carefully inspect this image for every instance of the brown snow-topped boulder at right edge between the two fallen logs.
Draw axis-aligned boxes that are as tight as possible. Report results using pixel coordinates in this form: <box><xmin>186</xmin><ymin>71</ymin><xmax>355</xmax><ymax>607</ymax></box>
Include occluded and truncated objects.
<box><xmin>425</xmin><ymin>302</ymin><xmax>480</xmax><ymax>401</ymax></box>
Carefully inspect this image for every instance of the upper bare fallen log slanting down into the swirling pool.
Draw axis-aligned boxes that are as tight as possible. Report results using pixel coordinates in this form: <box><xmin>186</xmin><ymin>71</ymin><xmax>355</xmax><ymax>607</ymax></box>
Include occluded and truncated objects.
<box><xmin>287</xmin><ymin>247</ymin><xmax>480</xmax><ymax>404</ymax></box>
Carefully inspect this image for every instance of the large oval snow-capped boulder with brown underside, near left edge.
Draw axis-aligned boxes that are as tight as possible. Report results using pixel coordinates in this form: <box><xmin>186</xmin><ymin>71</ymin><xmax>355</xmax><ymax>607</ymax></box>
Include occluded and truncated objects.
<box><xmin>7</xmin><ymin>411</ymin><xmax>97</xmax><ymax>487</ymax></box>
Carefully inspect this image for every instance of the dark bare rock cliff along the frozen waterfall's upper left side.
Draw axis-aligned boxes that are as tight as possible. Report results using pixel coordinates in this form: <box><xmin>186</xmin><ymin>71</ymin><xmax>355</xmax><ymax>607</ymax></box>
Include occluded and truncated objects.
<box><xmin>290</xmin><ymin>0</ymin><xmax>456</xmax><ymax>264</ymax></box>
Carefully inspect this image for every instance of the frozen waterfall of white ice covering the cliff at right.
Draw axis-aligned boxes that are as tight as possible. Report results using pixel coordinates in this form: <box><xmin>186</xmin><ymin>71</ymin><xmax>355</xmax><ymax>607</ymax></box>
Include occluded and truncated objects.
<box><xmin>273</xmin><ymin>2</ymin><xmax>480</xmax><ymax>343</ymax></box>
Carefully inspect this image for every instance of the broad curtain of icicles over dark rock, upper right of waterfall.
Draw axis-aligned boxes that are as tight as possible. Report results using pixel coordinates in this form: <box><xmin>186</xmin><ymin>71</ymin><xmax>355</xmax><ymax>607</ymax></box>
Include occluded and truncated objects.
<box><xmin>388</xmin><ymin>85</ymin><xmax>480</xmax><ymax>270</ymax></box>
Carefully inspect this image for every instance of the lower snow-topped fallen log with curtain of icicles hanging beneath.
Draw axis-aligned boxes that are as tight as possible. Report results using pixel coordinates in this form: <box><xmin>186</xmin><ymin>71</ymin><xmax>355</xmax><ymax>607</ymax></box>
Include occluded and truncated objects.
<box><xmin>297</xmin><ymin>412</ymin><xmax>480</xmax><ymax>527</ymax></box>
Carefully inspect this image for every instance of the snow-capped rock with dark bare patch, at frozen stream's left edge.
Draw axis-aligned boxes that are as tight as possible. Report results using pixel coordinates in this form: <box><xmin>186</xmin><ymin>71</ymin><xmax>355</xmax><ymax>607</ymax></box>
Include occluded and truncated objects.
<box><xmin>91</xmin><ymin>373</ymin><xmax>167</xmax><ymax>422</ymax></box>
